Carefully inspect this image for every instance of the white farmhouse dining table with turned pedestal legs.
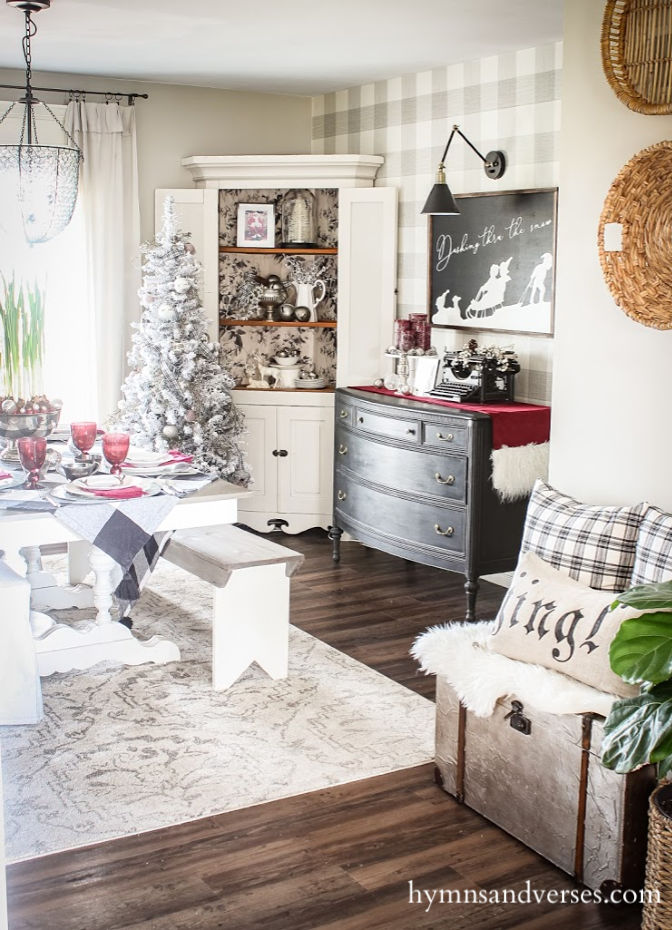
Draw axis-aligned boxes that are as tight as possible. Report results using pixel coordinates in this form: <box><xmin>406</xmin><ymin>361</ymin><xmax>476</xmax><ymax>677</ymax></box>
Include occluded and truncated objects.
<box><xmin>0</xmin><ymin>480</ymin><xmax>252</xmax><ymax>676</ymax></box>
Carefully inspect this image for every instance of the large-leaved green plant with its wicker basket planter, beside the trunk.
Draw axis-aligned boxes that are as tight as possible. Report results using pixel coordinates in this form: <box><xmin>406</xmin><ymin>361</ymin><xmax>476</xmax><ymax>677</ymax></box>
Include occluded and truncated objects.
<box><xmin>601</xmin><ymin>581</ymin><xmax>672</xmax><ymax>930</ymax></box>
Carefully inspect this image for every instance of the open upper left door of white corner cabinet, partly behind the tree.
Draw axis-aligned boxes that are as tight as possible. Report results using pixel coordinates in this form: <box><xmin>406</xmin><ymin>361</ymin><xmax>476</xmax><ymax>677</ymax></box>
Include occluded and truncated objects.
<box><xmin>154</xmin><ymin>188</ymin><xmax>219</xmax><ymax>342</ymax></box>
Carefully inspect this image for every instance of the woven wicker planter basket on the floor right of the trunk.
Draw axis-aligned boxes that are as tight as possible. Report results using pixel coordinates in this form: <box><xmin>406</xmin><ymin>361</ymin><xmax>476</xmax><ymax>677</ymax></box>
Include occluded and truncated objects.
<box><xmin>642</xmin><ymin>784</ymin><xmax>672</xmax><ymax>930</ymax></box>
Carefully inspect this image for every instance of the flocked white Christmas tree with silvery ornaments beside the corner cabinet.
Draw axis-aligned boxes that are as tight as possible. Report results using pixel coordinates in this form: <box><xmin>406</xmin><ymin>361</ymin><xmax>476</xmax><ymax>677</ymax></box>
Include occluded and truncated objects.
<box><xmin>114</xmin><ymin>197</ymin><xmax>249</xmax><ymax>484</ymax></box>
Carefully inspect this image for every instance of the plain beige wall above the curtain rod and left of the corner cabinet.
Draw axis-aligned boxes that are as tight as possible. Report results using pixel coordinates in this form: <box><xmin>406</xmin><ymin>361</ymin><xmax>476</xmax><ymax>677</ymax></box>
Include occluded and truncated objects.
<box><xmin>0</xmin><ymin>70</ymin><xmax>311</xmax><ymax>239</ymax></box>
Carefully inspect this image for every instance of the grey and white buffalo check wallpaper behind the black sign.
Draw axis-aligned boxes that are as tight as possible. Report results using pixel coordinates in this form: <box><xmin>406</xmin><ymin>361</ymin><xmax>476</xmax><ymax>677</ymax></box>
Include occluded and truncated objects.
<box><xmin>312</xmin><ymin>43</ymin><xmax>562</xmax><ymax>403</ymax></box>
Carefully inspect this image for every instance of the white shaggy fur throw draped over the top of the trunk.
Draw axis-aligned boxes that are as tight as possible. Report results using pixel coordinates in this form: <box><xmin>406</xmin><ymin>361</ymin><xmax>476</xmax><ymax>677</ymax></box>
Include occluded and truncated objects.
<box><xmin>411</xmin><ymin>621</ymin><xmax>616</xmax><ymax>717</ymax></box>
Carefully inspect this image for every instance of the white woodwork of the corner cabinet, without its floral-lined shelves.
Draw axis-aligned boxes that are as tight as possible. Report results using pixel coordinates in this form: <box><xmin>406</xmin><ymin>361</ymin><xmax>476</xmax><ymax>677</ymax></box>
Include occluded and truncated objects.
<box><xmin>157</xmin><ymin>155</ymin><xmax>397</xmax><ymax>533</ymax></box>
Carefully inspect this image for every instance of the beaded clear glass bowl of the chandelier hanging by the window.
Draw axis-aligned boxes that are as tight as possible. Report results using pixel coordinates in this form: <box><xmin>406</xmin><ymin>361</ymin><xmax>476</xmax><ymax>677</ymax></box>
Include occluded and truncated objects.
<box><xmin>0</xmin><ymin>144</ymin><xmax>81</xmax><ymax>243</ymax></box>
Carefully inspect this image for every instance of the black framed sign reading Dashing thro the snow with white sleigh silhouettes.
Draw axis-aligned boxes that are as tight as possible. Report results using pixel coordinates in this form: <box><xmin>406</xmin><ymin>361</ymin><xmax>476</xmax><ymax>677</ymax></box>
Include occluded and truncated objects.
<box><xmin>429</xmin><ymin>188</ymin><xmax>557</xmax><ymax>335</ymax></box>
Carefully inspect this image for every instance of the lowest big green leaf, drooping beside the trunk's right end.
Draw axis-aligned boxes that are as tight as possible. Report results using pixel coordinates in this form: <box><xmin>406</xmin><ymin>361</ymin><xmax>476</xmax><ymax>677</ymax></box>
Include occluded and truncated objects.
<box><xmin>601</xmin><ymin>682</ymin><xmax>672</xmax><ymax>774</ymax></box>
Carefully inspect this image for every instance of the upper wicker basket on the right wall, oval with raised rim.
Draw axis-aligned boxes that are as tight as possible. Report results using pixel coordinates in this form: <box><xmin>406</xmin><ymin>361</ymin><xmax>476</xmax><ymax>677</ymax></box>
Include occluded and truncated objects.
<box><xmin>601</xmin><ymin>0</ymin><xmax>672</xmax><ymax>114</ymax></box>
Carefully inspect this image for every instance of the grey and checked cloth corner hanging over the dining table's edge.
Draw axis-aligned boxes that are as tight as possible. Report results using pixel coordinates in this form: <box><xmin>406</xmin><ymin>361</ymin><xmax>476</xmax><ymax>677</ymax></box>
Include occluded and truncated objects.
<box><xmin>54</xmin><ymin>494</ymin><xmax>177</xmax><ymax>616</ymax></box>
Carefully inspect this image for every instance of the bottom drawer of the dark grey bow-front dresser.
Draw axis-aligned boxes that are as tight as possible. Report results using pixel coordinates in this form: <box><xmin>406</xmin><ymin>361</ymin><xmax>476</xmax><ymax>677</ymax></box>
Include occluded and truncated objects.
<box><xmin>334</xmin><ymin>468</ymin><xmax>466</xmax><ymax>556</ymax></box>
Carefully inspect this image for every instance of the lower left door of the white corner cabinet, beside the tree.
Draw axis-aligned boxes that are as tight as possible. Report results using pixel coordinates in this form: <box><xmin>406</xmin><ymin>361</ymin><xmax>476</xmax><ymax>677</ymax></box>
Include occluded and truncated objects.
<box><xmin>239</xmin><ymin>404</ymin><xmax>279</xmax><ymax>512</ymax></box>
